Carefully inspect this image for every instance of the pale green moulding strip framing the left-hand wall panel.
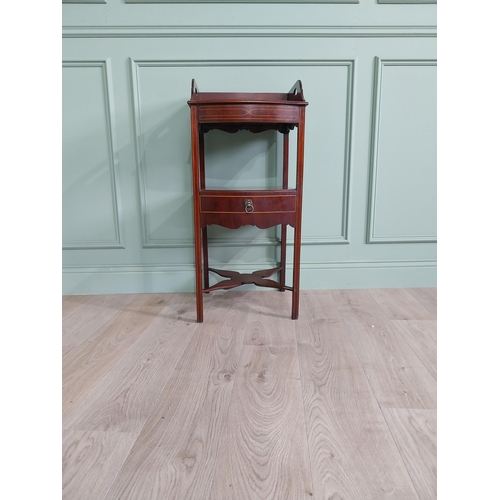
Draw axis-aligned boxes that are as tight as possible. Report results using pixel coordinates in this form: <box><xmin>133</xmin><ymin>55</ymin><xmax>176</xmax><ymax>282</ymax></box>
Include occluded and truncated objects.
<box><xmin>63</xmin><ymin>58</ymin><xmax>125</xmax><ymax>250</ymax></box>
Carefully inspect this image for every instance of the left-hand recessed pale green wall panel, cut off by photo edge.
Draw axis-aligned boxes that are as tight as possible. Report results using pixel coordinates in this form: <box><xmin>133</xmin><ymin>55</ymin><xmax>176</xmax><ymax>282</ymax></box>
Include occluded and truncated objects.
<box><xmin>62</xmin><ymin>61</ymin><xmax>122</xmax><ymax>249</ymax></box>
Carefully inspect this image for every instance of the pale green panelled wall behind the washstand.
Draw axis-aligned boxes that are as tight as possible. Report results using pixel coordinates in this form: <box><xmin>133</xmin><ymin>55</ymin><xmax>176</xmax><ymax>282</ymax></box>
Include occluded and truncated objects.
<box><xmin>63</xmin><ymin>0</ymin><xmax>436</xmax><ymax>294</ymax></box>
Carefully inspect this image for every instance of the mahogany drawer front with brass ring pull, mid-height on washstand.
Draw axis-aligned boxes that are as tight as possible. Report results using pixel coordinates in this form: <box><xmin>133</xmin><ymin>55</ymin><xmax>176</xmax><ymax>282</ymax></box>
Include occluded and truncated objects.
<box><xmin>201</xmin><ymin>195</ymin><xmax>296</xmax><ymax>215</ymax></box>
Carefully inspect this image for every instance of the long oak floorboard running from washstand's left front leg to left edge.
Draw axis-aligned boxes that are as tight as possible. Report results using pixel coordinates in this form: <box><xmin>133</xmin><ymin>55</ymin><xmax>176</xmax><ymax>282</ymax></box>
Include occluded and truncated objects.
<box><xmin>64</xmin><ymin>294</ymin><xmax>197</xmax><ymax>433</ymax></box>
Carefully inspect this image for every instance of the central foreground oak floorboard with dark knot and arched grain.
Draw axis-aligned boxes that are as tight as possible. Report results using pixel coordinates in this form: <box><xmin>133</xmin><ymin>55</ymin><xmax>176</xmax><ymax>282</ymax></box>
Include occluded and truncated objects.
<box><xmin>209</xmin><ymin>345</ymin><xmax>312</xmax><ymax>500</ymax></box>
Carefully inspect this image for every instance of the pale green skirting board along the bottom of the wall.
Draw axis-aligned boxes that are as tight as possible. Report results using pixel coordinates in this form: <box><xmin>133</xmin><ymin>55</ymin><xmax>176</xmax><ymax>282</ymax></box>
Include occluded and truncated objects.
<box><xmin>62</xmin><ymin>260</ymin><xmax>437</xmax><ymax>295</ymax></box>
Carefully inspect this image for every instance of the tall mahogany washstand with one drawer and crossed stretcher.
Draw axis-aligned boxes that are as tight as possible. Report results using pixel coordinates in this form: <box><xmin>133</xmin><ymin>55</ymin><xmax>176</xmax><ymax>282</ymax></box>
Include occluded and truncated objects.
<box><xmin>188</xmin><ymin>80</ymin><xmax>308</xmax><ymax>323</ymax></box>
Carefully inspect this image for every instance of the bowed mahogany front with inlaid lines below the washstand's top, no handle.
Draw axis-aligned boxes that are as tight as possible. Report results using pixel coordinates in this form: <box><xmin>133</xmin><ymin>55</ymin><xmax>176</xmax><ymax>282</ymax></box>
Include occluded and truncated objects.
<box><xmin>198</xmin><ymin>104</ymin><xmax>299</xmax><ymax>123</ymax></box>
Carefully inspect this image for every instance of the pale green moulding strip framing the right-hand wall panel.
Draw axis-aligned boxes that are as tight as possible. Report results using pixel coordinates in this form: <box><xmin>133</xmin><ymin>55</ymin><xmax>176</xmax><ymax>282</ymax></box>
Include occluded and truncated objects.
<box><xmin>366</xmin><ymin>57</ymin><xmax>437</xmax><ymax>243</ymax></box>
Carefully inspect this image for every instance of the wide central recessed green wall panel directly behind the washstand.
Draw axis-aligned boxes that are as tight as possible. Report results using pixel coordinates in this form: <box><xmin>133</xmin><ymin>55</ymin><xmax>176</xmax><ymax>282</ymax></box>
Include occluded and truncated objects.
<box><xmin>131</xmin><ymin>61</ymin><xmax>354</xmax><ymax>246</ymax></box>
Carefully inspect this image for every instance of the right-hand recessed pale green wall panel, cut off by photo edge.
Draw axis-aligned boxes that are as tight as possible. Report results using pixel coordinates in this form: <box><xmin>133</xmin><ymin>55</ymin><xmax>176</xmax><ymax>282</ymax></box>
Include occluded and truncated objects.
<box><xmin>368</xmin><ymin>59</ymin><xmax>437</xmax><ymax>243</ymax></box>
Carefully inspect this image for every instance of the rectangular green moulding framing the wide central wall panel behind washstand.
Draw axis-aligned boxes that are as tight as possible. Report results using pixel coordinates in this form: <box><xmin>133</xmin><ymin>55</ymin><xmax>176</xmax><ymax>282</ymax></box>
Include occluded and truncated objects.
<box><xmin>130</xmin><ymin>59</ymin><xmax>355</xmax><ymax>248</ymax></box>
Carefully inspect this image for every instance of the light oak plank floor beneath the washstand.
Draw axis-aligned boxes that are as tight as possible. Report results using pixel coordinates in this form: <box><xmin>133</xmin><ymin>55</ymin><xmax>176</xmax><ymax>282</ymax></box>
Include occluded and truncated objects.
<box><xmin>62</xmin><ymin>288</ymin><xmax>436</xmax><ymax>500</ymax></box>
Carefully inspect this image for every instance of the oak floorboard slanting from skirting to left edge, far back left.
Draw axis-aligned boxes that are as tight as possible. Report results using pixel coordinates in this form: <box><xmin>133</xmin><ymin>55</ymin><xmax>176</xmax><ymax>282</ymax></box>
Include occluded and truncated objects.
<box><xmin>62</xmin><ymin>295</ymin><xmax>138</xmax><ymax>348</ymax></box>
